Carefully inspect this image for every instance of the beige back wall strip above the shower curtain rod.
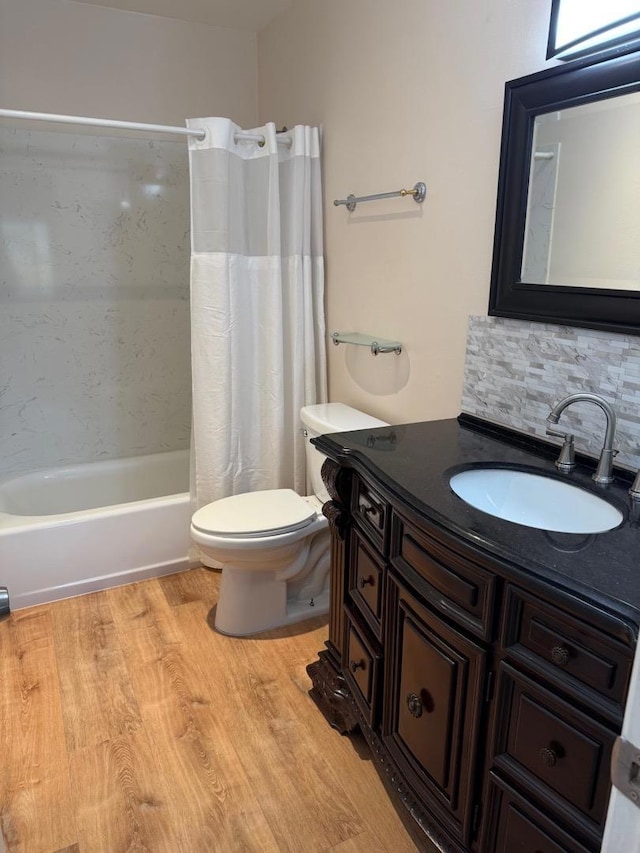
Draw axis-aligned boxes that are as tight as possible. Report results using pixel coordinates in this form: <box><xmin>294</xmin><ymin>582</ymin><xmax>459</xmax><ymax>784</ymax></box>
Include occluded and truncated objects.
<box><xmin>0</xmin><ymin>0</ymin><xmax>257</xmax><ymax>126</ymax></box>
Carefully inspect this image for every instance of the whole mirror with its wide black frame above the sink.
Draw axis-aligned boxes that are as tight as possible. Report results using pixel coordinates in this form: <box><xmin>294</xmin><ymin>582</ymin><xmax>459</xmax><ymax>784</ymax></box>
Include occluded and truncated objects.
<box><xmin>489</xmin><ymin>45</ymin><xmax>640</xmax><ymax>334</ymax></box>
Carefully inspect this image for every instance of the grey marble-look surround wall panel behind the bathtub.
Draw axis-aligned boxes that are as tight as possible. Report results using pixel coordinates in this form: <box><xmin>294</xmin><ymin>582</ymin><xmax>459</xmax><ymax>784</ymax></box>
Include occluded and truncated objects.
<box><xmin>0</xmin><ymin>125</ymin><xmax>191</xmax><ymax>476</ymax></box>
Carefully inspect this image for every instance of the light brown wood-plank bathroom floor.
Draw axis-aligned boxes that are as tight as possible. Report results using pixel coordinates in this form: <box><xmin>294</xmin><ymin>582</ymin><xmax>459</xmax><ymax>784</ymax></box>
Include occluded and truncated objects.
<box><xmin>0</xmin><ymin>569</ymin><xmax>418</xmax><ymax>853</ymax></box>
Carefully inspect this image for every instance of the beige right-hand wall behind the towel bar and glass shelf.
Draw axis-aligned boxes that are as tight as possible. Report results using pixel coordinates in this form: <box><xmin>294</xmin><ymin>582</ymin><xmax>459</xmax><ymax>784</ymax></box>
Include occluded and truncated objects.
<box><xmin>258</xmin><ymin>0</ymin><xmax>550</xmax><ymax>423</ymax></box>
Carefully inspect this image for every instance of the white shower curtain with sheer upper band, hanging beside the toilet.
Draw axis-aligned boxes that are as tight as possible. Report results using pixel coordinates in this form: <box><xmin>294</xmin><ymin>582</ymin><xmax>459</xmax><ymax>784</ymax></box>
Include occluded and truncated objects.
<box><xmin>187</xmin><ymin>118</ymin><xmax>327</xmax><ymax>507</ymax></box>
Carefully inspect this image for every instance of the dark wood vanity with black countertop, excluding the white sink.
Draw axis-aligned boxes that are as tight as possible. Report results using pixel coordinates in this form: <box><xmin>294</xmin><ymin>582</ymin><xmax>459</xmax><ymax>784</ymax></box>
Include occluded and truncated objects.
<box><xmin>308</xmin><ymin>416</ymin><xmax>640</xmax><ymax>853</ymax></box>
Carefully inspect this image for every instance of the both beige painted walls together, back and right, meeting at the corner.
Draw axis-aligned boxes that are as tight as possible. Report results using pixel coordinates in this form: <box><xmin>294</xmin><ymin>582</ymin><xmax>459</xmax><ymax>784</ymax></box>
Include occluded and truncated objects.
<box><xmin>0</xmin><ymin>0</ymin><xmax>550</xmax><ymax>422</ymax></box>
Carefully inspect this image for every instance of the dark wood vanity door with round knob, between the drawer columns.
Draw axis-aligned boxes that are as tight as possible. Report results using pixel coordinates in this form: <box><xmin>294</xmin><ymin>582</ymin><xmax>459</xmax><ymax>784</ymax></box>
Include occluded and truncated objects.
<box><xmin>383</xmin><ymin>575</ymin><xmax>484</xmax><ymax>843</ymax></box>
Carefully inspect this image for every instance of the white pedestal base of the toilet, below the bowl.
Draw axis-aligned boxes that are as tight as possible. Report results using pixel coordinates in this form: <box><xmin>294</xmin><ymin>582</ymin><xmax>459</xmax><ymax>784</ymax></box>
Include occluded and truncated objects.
<box><xmin>214</xmin><ymin>568</ymin><xmax>329</xmax><ymax>637</ymax></box>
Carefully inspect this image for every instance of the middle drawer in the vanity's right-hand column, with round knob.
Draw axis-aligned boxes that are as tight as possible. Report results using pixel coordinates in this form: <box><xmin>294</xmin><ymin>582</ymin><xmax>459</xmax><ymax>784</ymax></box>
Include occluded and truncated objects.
<box><xmin>495</xmin><ymin>663</ymin><xmax>615</xmax><ymax>826</ymax></box>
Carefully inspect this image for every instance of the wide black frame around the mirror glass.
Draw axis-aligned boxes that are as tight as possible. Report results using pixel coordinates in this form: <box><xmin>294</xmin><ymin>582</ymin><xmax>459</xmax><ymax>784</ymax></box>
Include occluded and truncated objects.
<box><xmin>489</xmin><ymin>45</ymin><xmax>640</xmax><ymax>335</ymax></box>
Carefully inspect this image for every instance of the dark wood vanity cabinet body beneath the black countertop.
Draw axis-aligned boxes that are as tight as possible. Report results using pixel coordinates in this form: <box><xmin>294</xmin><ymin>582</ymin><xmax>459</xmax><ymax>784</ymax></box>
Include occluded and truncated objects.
<box><xmin>308</xmin><ymin>459</ymin><xmax>633</xmax><ymax>853</ymax></box>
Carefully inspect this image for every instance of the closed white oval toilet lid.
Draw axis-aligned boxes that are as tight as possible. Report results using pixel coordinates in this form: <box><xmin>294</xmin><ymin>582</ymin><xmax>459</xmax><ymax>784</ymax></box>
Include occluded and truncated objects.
<box><xmin>191</xmin><ymin>489</ymin><xmax>316</xmax><ymax>536</ymax></box>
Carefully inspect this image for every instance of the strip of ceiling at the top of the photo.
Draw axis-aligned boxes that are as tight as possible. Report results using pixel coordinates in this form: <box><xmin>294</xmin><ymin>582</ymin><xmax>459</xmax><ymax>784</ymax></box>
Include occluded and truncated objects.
<box><xmin>69</xmin><ymin>0</ymin><xmax>292</xmax><ymax>32</ymax></box>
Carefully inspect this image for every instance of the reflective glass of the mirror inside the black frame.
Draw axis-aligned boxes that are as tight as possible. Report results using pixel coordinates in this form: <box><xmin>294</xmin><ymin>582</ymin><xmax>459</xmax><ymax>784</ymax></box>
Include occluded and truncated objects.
<box><xmin>521</xmin><ymin>92</ymin><xmax>640</xmax><ymax>290</ymax></box>
